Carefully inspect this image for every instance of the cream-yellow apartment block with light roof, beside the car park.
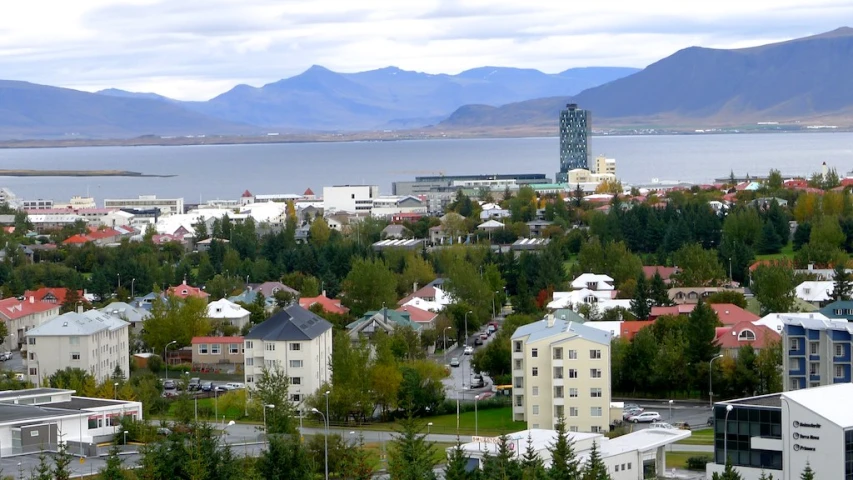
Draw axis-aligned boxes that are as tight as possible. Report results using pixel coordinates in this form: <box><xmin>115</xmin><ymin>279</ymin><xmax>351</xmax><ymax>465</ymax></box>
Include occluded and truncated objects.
<box><xmin>512</xmin><ymin>314</ymin><xmax>611</xmax><ymax>433</ymax></box>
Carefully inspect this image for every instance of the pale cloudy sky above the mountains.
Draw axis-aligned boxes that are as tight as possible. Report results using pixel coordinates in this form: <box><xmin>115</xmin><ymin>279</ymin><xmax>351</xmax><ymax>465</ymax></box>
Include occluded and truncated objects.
<box><xmin>0</xmin><ymin>0</ymin><xmax>853</xmax><ymax>100</ymax></box>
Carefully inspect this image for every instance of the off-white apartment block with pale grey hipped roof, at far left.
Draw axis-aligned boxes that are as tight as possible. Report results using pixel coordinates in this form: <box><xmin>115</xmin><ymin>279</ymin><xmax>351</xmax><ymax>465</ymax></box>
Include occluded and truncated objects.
<box><xmin>25</xmin><ymin>310</ymin><xmax>130</xmax><ymax>385</ymax></box>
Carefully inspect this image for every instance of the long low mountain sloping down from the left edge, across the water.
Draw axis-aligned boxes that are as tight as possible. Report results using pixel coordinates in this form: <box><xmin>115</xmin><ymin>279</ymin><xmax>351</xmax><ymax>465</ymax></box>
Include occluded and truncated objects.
<box><xmin>0</xmin><ymin>80</ymin><xmax>257</xmax><ymax>139</ymax></box>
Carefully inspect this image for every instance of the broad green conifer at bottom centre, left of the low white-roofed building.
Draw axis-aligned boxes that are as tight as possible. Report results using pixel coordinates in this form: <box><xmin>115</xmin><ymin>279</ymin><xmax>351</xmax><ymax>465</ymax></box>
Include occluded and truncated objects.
<box><xmin>388</xmin><ymin>410</ymin><xmax>437</xmax><ymax>480</ymax></box>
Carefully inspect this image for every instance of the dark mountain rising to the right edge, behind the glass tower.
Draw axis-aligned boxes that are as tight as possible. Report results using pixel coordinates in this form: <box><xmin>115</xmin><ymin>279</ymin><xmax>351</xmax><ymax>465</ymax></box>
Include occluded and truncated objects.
<box><xmin>441</xmin><ymin>27</ymin><xmax>853</xmax><ymax>127</ymax></box>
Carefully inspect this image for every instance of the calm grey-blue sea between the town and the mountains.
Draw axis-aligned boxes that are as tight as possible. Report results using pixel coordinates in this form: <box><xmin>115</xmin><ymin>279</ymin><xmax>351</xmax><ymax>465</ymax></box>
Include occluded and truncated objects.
<box><xmin>0</xmin><ymin>132</ymin><xmax>853</xmax><ymax>203</ymax></box>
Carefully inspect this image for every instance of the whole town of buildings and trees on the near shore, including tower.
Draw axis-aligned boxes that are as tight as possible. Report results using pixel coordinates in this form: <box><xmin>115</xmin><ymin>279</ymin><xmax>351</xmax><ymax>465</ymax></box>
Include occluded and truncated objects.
<box><xmin>0</xmin><ymin>104</ymin><xmax>853</xmax><ymax>480</ymax></box>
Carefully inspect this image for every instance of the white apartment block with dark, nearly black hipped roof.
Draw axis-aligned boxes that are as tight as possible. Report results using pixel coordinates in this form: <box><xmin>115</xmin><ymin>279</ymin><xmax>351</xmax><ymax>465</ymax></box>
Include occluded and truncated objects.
<box><xmin>243</xmin><ymin>305</ymin><xmax>332</xmax><ymax>403</ymax></box>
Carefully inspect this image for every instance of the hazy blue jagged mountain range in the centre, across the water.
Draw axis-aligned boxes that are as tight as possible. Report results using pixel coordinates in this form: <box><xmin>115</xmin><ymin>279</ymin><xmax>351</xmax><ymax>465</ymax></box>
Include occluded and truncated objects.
<box><xmin>186</xmin><ymin>65</ymin><xmax>637</xmax><ymax>130</ymax></box>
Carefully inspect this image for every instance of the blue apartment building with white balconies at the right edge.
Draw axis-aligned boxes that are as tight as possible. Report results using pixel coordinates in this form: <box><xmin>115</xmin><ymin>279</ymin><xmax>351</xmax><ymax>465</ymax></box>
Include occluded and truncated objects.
<box><xmin>782</xmin><ymin>317</ymin><xmax>853</xmax><ymax>391</ymax></box>
